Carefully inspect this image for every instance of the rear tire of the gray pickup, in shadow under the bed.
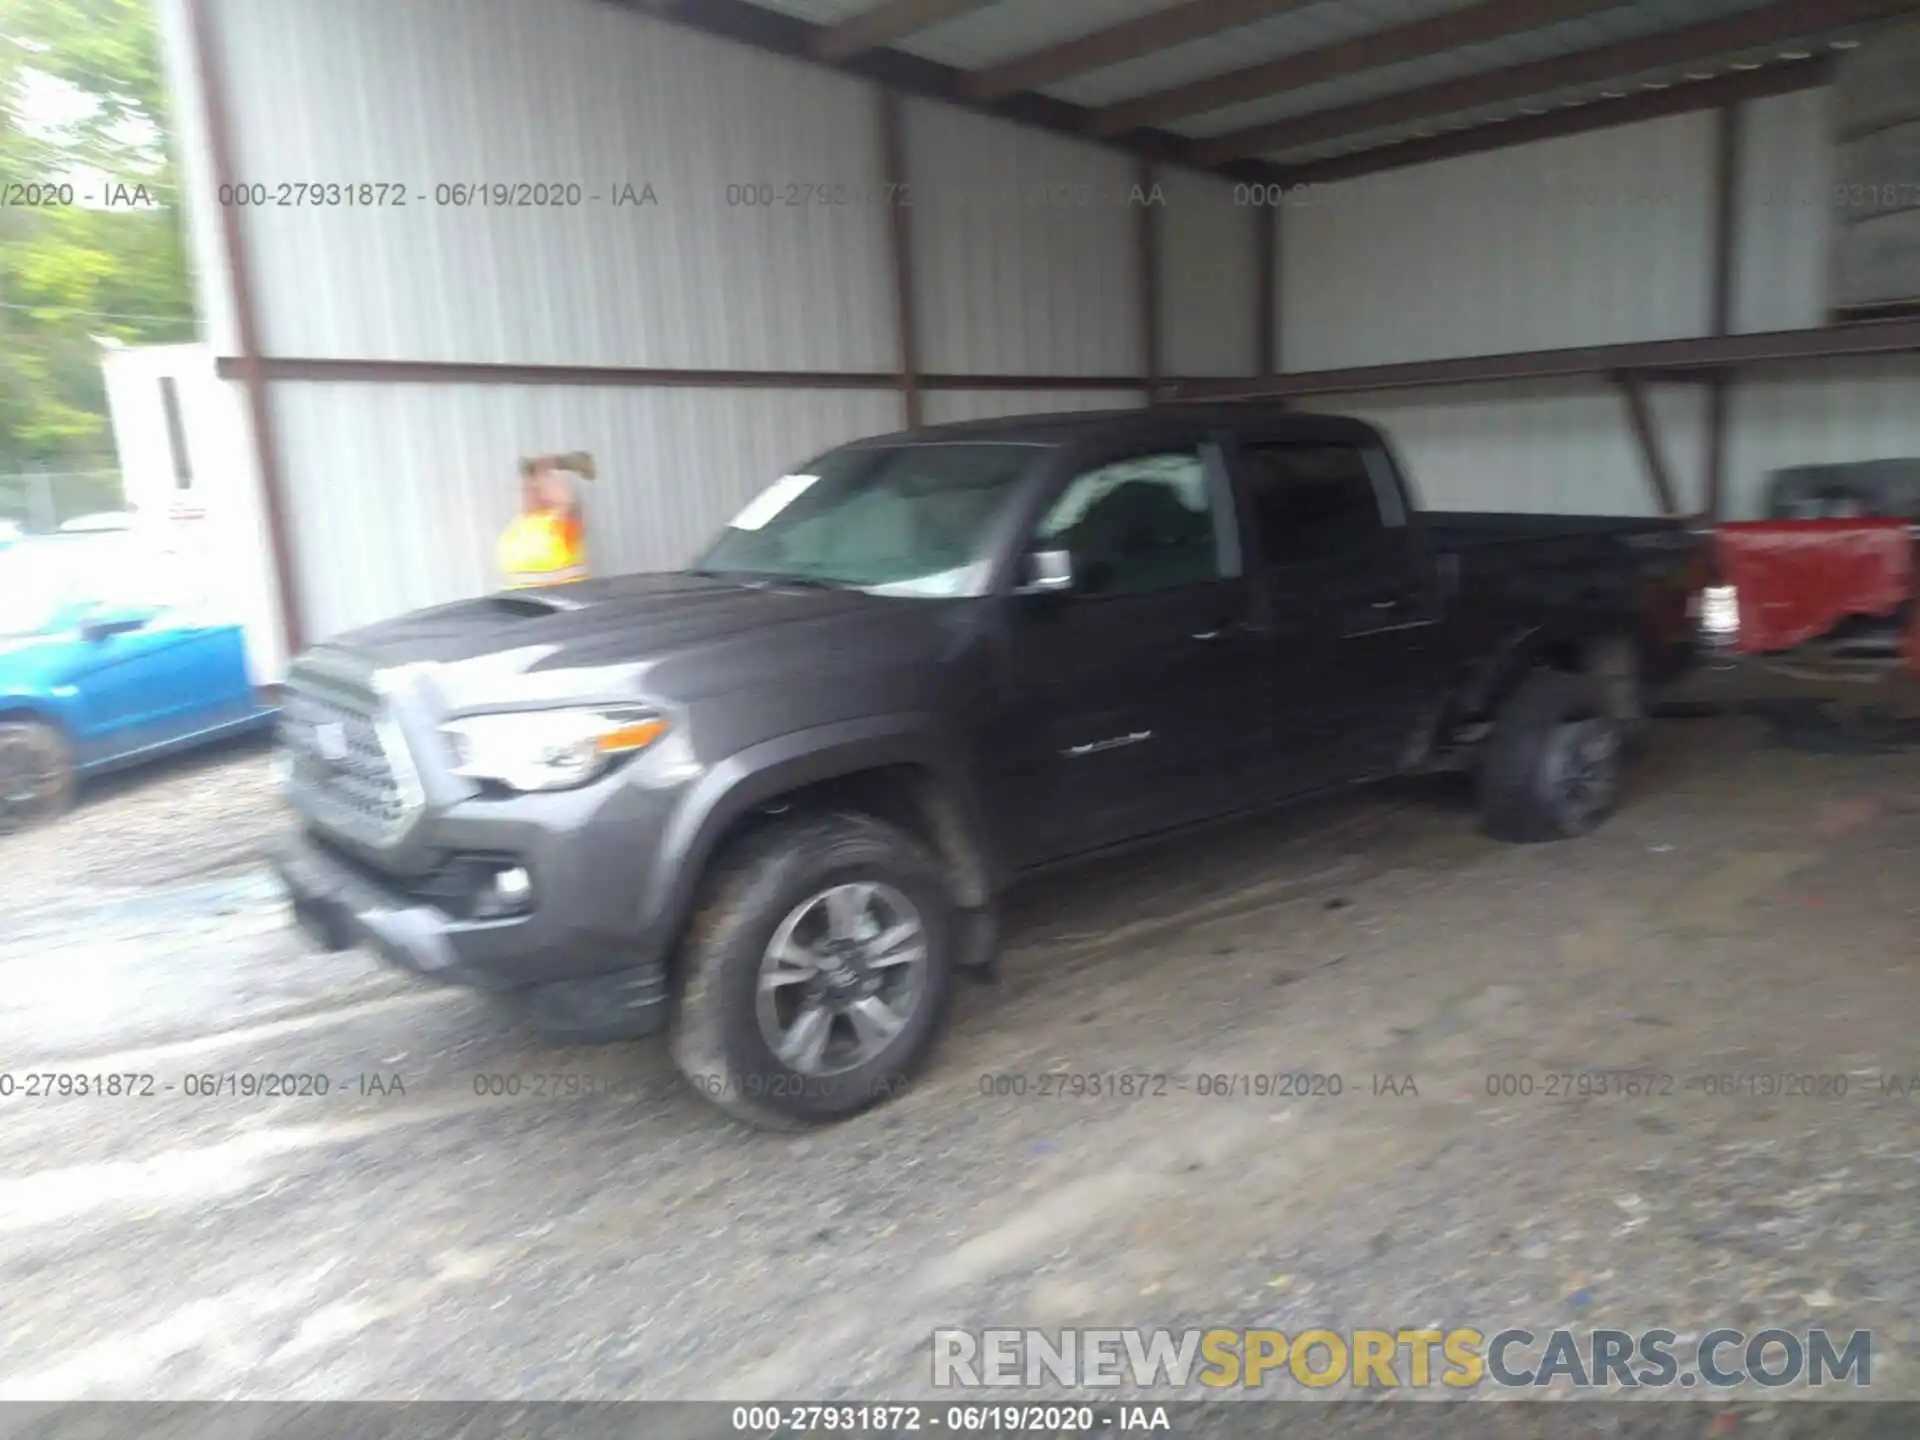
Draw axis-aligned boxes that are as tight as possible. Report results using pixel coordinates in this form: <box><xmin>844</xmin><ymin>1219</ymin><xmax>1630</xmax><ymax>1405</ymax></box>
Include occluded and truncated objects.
<box><xmin>1480</xmin><ymin>670</ymin><xmax>1624</xmax><ymax>845</ymax></box>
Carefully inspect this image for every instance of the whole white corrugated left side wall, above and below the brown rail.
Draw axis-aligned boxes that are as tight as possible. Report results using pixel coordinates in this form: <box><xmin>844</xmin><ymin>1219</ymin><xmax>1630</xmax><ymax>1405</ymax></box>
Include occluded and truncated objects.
<box><xmin>163</xmin><ymin>0</ymin><xmax>1182</xmax><ymax>637</ymax></box>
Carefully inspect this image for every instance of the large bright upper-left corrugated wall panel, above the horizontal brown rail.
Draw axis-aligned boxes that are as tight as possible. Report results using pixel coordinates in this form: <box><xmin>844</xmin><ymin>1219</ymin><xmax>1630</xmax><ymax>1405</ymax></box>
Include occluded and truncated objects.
<box><xmin>196</xmin><ymin>0</ymin><xmax>893</xmax><ymax>371</ymax></box>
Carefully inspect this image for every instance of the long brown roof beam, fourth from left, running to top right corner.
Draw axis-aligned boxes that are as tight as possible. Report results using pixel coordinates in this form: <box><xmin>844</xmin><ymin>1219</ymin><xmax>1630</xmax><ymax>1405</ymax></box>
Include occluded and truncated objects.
<box><xmin>1194</xmin><ymin>0</ymin><xmax>1920</xmax><ymax>165</ymax></box>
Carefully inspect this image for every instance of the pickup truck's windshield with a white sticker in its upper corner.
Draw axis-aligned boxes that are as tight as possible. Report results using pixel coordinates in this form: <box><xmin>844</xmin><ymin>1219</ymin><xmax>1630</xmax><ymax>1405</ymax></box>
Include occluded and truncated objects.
<box><xmin>695</xmin><ymin>444</ymin><xmax>1037</xmax><ymax>595</ymax></box>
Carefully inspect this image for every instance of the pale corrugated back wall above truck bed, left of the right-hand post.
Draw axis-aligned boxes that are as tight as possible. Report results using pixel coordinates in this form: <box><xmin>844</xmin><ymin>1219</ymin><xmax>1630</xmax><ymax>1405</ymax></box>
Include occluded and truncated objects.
<box><xmin>1281</xmin><ymin>115</ymin><xmax>1713</xmax><ymax>515</ymax></box>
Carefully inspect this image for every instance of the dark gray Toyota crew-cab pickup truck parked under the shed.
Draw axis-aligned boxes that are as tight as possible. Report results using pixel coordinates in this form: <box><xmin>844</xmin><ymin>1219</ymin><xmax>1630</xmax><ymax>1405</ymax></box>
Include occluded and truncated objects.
<box><xmin>276</xmin><ymin>405</ymin><xmax>1707</xmax><ymax>1127</ymax></box>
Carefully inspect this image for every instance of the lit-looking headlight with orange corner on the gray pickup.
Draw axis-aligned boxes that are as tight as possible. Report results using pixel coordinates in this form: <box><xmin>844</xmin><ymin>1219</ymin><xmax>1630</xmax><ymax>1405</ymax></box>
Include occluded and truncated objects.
<box><xmin>440</xmin><ymin>705</ymin><xmax>668</xmax><ymax>791</ymax></box>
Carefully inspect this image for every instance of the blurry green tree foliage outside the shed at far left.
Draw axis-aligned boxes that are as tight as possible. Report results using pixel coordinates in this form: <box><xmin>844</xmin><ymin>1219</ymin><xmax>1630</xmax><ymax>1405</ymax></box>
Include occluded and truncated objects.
<box><xmin>0</xmin><ymin>0</ymin><xmax>194</xmax><ymax>491</ymax></box>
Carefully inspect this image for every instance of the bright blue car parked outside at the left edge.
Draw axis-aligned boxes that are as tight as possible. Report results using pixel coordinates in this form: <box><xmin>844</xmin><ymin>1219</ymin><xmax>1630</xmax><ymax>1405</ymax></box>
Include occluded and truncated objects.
<box><xmin>0</xmin><ymin>532</ymin><xmax>276</xmax><ymax>833</ymax></box>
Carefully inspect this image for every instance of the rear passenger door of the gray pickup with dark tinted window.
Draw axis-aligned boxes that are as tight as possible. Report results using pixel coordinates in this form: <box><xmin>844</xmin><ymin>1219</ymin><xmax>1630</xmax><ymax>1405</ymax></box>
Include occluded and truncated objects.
<box><xmin>1236</xmin><ymin>432</ymin><xmax>1444</xmax><ymax>787</ymax></box>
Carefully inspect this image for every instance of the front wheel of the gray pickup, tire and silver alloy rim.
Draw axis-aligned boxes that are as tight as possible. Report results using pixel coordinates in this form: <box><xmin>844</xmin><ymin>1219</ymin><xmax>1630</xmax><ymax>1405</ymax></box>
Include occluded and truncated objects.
<box><xmin>674</xmin><ymin>814</ymin><xmax>958</xmax><ymax>1131</ymax></box>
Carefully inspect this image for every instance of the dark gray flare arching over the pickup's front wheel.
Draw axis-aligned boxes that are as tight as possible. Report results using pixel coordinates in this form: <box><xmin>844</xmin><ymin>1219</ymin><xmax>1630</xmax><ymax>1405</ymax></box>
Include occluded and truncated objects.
<box><xmin>641</xmin><ymin>714</ymin><xmax>987</xmax><ymax>963</ymax></box>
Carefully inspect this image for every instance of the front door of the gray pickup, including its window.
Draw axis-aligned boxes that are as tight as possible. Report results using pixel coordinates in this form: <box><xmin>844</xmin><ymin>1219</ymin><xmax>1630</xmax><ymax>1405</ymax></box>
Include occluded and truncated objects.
<box><xmin>1004</xmin><ymin>436</ymin><xmax>1267</xmax><ymax>862</ymax></box>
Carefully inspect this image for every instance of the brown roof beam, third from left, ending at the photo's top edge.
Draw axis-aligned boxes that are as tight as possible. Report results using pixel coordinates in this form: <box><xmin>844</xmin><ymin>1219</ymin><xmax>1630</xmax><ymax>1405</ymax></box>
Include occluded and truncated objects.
<box><xmin>1091</xmin><ymin>0</ymin><xmax>1630</xmax><ymax>134</ymax></box>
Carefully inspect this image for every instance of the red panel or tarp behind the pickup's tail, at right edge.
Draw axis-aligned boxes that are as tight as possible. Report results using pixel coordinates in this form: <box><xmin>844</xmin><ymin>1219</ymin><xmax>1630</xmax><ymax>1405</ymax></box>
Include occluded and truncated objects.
<box><xmin>1720</xmin><ymin>518</ymin><xmax>1914</xmax><ymax>651</ymax></box>
